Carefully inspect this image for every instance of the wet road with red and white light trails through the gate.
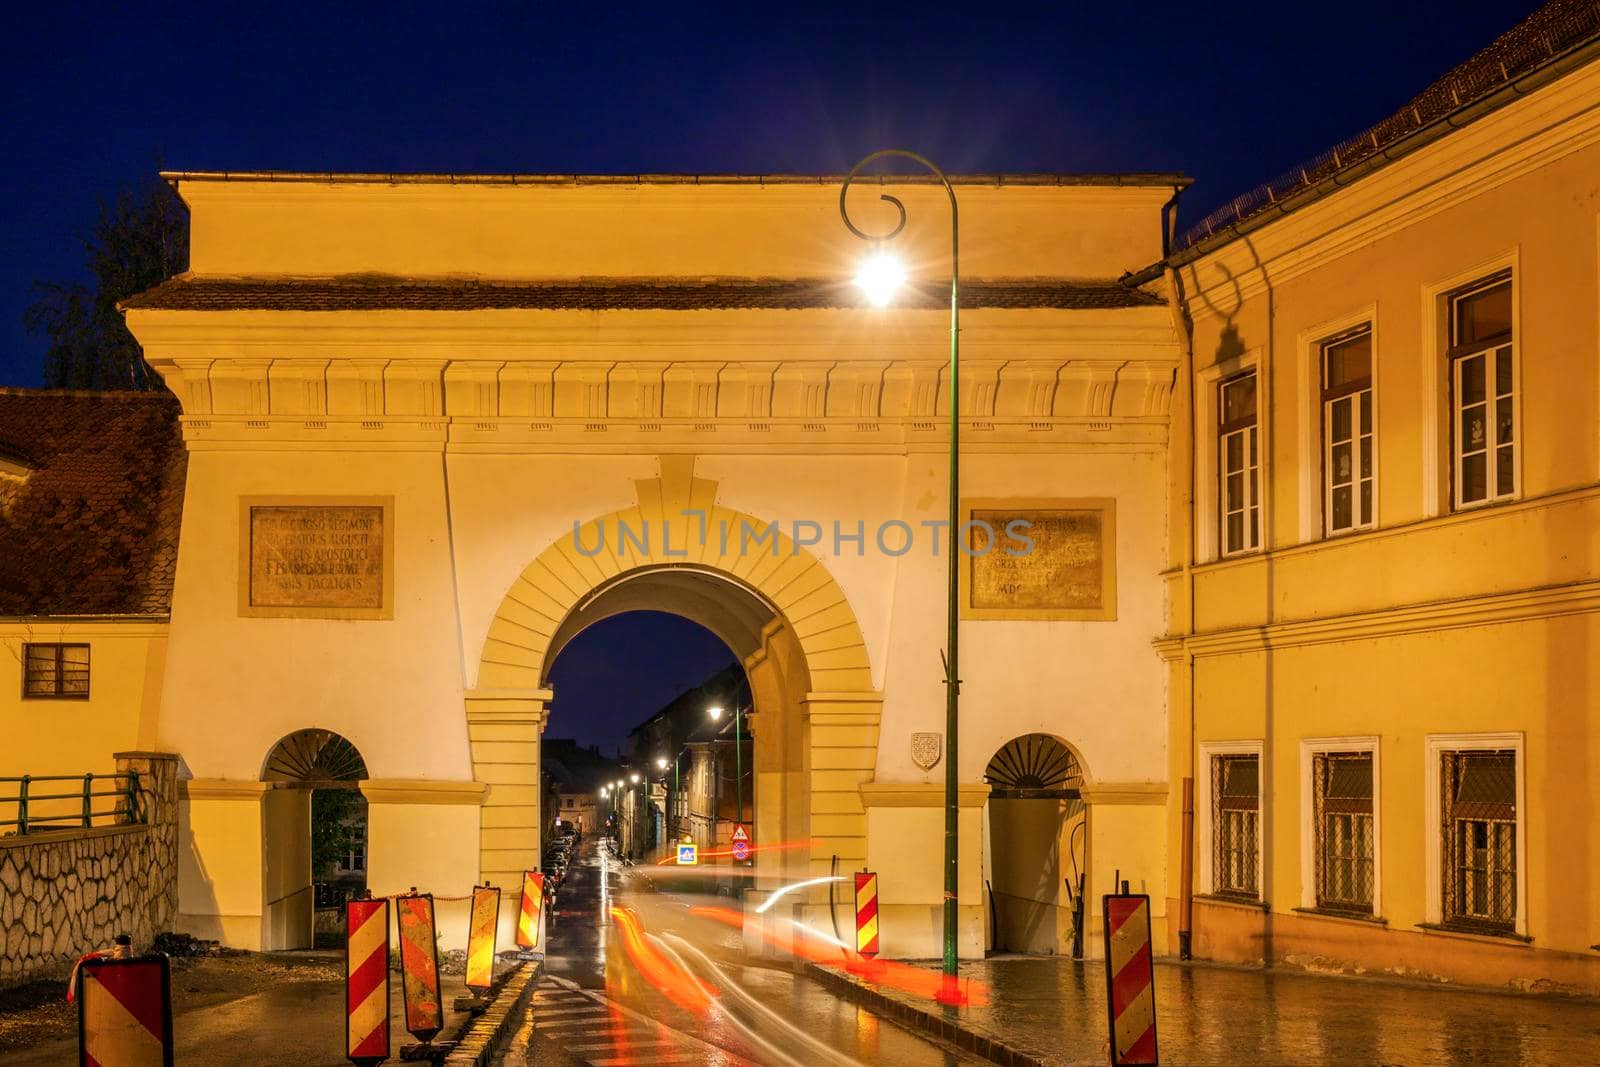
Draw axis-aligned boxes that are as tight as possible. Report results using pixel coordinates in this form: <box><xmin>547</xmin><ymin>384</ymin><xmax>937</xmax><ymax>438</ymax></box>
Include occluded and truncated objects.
<box><xmin>501</xmin><ymin>840</ymin><xmax>982</xmax><ymax>1067</ymax></box>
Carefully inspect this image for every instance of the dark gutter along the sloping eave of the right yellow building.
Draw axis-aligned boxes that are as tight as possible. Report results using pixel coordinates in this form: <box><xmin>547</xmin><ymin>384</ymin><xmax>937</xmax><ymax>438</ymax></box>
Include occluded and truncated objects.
<box><xmin>1120</xmin><ymin>28</ymin><xmax>1600</xmax><ymax>286</ymax></box>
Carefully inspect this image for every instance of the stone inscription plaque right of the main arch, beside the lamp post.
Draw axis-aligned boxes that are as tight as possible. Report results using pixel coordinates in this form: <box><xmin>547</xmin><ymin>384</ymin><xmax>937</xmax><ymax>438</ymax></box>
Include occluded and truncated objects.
<box><xmin>965</xmin><ymin>499</ymin><xmax>1117</xmax><ymax>619</ymax></box>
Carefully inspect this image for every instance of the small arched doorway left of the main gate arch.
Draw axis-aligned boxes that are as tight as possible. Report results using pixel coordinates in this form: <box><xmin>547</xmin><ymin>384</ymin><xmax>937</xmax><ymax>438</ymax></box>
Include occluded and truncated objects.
<box><xmin>261</xmin><ymin>729</ymin><xmax>366</xmax><ymax>949</ymax></box>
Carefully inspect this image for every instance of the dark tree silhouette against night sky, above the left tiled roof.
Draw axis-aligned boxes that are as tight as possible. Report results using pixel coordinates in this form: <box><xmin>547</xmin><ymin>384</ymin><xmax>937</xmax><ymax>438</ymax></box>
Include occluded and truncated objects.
<box><xmin>24</xmin><ymin>179</ymin><xmax>189</xmax><ymax>389</ymax></box>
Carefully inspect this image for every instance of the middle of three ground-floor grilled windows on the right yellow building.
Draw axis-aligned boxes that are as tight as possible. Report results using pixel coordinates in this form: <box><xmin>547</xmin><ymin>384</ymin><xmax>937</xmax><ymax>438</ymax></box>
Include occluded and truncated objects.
<box><xmin>1312</xmin><ymin>752</ymin><xmax>1373</xmax><ymax>915</ymax></box>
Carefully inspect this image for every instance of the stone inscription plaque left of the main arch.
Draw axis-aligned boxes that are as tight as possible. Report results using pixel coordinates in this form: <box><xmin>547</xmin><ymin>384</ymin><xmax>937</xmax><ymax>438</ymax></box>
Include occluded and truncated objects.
<box><xmin>240</xmin><ymin>501</ymin><xmax>392</xmax><ymax>617</ymax></box>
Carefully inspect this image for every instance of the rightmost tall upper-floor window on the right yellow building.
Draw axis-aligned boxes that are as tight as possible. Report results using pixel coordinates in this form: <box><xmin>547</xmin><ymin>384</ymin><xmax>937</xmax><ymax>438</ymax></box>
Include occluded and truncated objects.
<box><xmin>1450</xmin><ymin>275</ymin><xmax>1517</xmax><ymax>507</ymax></box>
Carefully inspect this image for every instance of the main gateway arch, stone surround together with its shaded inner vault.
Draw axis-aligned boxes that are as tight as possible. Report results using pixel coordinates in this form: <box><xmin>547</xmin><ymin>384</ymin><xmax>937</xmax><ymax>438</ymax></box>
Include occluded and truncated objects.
<box><xmin>467</xmin><ymin>456</ymin><xmax>882</xmax><ymax>901</ymax></box>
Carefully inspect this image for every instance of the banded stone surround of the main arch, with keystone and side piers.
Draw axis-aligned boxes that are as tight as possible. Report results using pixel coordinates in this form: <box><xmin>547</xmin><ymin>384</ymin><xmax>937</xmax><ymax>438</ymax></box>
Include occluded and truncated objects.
<box><xmin>467</xmin><ymin>456</ymin><xmax>883</xmax><ymax>885</ymax></box>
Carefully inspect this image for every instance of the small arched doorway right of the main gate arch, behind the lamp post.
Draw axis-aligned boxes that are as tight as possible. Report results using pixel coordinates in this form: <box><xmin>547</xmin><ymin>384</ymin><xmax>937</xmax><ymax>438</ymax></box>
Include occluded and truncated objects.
<box><xmin>984</xmin><ymin>734</ymin><xmax>1088</xmax><ymax>955</ymax></box>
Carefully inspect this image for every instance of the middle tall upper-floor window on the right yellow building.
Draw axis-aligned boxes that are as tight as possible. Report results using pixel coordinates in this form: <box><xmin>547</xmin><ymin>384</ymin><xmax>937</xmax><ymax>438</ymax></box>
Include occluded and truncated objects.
<box><xmin>1322</xmin><ymin>326</ymin><xmax>1373</xmax><ymax>534</ymax></box>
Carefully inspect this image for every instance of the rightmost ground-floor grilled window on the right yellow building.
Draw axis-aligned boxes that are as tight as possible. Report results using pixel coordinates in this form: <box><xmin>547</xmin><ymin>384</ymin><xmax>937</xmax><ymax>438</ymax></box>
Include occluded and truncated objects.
<box><xmin>1440</xmin><ymin>749</ymin><xmax>1517</xmax><ymax>933</ymax></box>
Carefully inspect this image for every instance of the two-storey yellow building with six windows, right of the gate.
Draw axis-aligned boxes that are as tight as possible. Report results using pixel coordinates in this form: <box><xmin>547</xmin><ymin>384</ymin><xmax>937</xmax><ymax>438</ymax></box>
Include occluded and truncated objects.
<box><xmin>1158</xmin><ymin>5</ymin><xmax>1600</xmax><ymax>992</ymax></box>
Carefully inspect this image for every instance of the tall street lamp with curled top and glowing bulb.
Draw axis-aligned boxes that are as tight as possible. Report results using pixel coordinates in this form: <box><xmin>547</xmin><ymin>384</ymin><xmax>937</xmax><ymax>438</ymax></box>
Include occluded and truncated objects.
<box><xmin>838</xmin><ymin>149</ymin><xmax>965</xmax><ymax>1005</ymax></box>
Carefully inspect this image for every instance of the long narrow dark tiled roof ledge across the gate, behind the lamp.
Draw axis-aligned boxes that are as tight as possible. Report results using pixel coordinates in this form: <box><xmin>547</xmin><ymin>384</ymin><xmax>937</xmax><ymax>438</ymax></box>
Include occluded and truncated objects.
<box><xmin>122</xmin><ymin>275</ymin><xmax>1162</xmax><ymax>312</ymax></box>
